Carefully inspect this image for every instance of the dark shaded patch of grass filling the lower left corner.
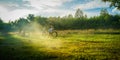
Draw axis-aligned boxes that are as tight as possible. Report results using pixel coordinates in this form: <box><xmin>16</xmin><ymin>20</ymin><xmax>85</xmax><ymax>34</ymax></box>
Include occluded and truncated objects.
<box><xmin>0</xmin><ymin>34</ymin><xmax>61</xmax><ymax>60</ymax></box>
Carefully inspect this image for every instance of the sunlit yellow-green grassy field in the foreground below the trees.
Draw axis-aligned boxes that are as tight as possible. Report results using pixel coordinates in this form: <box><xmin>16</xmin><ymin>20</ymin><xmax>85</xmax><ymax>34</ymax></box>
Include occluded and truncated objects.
<box><xmin>0</xmin><ymin>29</ymin><xmax>120</xmax><ymax>60</ymax></box>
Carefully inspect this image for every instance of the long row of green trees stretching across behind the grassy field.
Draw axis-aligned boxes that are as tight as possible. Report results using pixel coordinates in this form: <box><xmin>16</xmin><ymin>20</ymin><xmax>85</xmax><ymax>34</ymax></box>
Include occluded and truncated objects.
<box><xmin>0</xmin><ymin>9</ymin><xmax>120</xmax><ymax>32</ymax></box>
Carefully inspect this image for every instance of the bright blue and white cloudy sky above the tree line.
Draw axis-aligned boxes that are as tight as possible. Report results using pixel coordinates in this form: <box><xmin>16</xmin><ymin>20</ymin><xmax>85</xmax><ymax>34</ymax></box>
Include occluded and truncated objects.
<box><xmin>0</xmin><ymin>0</ymin><xmax>120</xmax><ymax>22</ymax></box>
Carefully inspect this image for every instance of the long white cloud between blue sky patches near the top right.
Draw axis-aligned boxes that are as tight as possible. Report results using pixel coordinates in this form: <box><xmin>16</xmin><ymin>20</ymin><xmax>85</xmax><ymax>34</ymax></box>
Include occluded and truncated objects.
<box><xmin>74</xmin><ymin>0</ymin><xmax>110</xmax><ymax>10</ymax></box>
